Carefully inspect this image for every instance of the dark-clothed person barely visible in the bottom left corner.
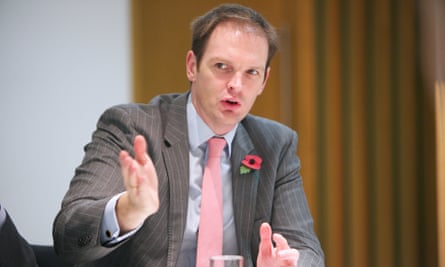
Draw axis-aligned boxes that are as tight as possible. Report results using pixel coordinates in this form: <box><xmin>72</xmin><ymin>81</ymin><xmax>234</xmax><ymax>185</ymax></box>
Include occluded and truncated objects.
<box><xmin>0</xmin><ymin>205</ymin><xmax>37</xmax><ymax>267</ymax></box>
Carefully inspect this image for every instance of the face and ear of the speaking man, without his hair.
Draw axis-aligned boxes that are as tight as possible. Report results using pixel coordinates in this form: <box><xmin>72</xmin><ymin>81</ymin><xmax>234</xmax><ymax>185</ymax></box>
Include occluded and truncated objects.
<box><xmin>186</xmin><ymin>22</ymin><xmax>269</xmax><ymax>134</ymax></box>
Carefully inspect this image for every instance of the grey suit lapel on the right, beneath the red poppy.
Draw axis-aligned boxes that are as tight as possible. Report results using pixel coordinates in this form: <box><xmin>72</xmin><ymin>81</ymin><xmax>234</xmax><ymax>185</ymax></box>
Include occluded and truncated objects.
<box><xmin>231</xmin><ymin>124</ymin><xmax>258</xmax><ymax>260</ymax></box>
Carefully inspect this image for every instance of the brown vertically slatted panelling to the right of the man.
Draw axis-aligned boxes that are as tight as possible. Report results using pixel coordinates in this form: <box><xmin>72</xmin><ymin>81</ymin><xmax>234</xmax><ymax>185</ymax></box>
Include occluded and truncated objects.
<box><xmin>288</xmin><ymin>0</ymin><xmax>437</xmax><ymax>267</ymax></box>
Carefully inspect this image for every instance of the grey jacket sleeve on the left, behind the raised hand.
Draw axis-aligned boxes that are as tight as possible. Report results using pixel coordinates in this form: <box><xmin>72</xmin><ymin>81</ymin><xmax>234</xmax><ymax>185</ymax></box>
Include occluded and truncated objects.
<box><xmin>53</xmin><ymin>106</ymin><xmax>137</xmax><ymax>263</ymax></box>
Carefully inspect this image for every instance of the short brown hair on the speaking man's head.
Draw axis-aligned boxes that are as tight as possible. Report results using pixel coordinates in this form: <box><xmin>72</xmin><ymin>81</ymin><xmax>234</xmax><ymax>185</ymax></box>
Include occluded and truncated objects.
<box><xmin>191</xmin><ymin>4</ymin><xmax>278</xmax><ymax>68</ymax></box>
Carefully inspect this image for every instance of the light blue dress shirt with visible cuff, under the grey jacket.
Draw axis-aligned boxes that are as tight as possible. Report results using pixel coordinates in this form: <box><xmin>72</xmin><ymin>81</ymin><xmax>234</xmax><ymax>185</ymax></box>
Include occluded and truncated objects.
<box><xmin>101</xmin><ymin>95</ymin><xmax>239</xmax><ymax>267</ymax></box>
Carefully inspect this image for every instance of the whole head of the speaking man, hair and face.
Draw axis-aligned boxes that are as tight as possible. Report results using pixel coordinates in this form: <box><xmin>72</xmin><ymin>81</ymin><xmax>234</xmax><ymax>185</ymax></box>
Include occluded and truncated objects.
<box><xmin>186</xmin><ymin>5</ymin><xmax>277</xmax><ymax>134</ymax></box>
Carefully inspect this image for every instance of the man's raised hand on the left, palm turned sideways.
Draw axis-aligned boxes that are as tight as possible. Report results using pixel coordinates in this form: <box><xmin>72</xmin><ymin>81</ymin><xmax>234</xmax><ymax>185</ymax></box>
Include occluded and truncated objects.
<box><xmin>116</xmin><ymin>135</ymin><xmax>159</xmax><ymax>234</ymax></box>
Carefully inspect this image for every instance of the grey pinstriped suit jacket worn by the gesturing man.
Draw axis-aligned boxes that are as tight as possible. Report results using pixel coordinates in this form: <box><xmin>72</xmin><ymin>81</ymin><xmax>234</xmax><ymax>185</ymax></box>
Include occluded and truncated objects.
<box><xmin>53</xmin><ymin>94</ymin><xmax>324</xmax><ymax>267</ymax></box>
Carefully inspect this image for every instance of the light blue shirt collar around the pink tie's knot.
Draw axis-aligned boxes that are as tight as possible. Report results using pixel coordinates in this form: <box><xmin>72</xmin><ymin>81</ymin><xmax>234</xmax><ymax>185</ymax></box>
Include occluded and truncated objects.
<box><xmin>187</xmin><ymin>93</ymin><xmax>239</xmax><ymax>157</ymax></box>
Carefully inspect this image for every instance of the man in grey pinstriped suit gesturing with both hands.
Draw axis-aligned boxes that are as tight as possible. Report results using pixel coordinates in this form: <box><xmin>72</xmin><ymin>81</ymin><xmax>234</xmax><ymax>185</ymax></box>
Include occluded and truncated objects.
<box><xmin>53</xmin><ymin>5</ymin><xmax>324</xmax><ymax>267</ymax></box>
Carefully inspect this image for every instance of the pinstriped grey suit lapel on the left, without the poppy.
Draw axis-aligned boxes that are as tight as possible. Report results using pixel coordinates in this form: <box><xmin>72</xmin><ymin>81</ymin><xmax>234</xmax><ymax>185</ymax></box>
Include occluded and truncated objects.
<box><xmin>162</xmin><ymin>94</ymin><xmax>189</xmax><ymax>267</ymax></box>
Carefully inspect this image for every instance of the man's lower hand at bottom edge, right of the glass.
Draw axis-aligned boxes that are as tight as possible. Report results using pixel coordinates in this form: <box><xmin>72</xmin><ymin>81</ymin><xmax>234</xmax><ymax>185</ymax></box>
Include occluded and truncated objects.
<box><xmin>257</xmin><ymin>223</ymin><xmax>299</xmax><ymax>267</ymax></box>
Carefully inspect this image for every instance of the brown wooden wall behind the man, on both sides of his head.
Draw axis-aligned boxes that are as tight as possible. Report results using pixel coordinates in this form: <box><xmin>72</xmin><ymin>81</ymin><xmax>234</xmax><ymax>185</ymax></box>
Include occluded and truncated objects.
<box><xmin>133</xmin><ymin>0</ymin><xmax>438</xmax><ymax>267</ymax></box>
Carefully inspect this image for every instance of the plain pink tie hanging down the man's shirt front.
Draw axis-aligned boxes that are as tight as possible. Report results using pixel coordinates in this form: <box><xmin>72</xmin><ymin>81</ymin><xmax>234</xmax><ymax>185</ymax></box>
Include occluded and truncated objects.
<box><xmin>196</xmin><ymin>137</ymin><xmax>226</xmax><ymax>267</ymax></box>
